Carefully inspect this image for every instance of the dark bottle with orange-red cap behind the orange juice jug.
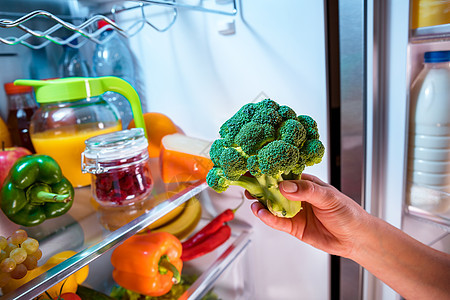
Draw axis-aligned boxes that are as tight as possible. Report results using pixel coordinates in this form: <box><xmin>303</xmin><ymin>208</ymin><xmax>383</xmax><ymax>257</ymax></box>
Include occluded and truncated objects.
<box><xmin>4</xmin><ymin>82</ymin><xmax>38</xmax><ymax>153</ymax></box>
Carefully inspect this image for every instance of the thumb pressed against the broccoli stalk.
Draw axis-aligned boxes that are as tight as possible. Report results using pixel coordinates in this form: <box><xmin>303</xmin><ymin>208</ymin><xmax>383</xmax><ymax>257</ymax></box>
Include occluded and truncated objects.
<box><xmin>279</xmin><ymin>180</ymin><xmax>333</xmax><ymax>208</ymax></box>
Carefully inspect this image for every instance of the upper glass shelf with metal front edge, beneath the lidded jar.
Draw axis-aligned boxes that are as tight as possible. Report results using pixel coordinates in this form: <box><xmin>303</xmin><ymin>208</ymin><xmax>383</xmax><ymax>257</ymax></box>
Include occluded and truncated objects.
<box><xmin>1</xmin><ymin>180</ymin><xmax>207</xmax><ymax>300</ymax></box>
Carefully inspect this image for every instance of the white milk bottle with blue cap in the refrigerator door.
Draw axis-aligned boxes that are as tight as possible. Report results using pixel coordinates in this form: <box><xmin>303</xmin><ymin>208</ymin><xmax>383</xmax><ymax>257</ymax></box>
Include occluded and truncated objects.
<box><xmin>408</xmin><ymin>51</ymin><xmax>450</xmax><ymax>212</ymax></box>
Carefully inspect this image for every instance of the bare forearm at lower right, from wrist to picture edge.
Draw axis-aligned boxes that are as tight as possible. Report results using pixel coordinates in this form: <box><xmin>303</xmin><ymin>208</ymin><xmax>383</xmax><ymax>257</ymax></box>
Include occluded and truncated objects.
<box><xmin>356</xmin><ymin>212</ymin><xmax>450</xmax><ymax>299</ymax></box>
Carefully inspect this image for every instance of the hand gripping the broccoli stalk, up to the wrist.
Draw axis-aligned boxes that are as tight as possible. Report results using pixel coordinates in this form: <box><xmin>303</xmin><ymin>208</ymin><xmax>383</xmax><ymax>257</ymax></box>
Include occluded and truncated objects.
<box><xmin>246</xmin><ymin>174</ymin><xmax>370</xmax><ymax>257</ymax></box>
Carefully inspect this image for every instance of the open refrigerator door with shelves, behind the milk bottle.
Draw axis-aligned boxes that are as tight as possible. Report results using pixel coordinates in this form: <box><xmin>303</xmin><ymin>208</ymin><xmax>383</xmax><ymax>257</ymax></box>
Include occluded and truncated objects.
<box><xmin>362</xmin><ymin>1</ymin><xmax>450</xmax><ymax>299</ymax></box>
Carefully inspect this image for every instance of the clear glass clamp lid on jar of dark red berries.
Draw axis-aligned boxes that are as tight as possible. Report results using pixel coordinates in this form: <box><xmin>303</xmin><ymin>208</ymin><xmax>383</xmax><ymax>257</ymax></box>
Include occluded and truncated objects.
<box><xmin>82</xmin><ymin>128</ymin><xmax>148</xmax><ymax>173</ymax></box>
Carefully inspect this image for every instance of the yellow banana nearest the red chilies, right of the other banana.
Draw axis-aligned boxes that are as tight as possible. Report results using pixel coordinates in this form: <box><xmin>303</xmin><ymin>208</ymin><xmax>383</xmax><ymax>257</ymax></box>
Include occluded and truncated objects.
<box><xmin>152</xmin><ymin>197</ymin><xmax>202</xmax><ymax>240</ymax></box>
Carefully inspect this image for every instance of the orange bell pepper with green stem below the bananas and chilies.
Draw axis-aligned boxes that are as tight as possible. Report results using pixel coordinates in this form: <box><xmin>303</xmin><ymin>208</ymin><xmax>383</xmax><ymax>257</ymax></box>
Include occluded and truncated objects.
<box><xmin>111</xmin><ymin>232</ymin><xmax>183</xmax><ymax>297</ymax></box>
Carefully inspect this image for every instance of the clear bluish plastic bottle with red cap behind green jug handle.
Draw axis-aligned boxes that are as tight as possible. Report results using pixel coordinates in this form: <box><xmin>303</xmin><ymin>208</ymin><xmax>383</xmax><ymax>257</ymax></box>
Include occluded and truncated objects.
<box><xmin>93</xmin><ymin>20</ymin><xmax>136</xmax><ymax>129</ymax></box>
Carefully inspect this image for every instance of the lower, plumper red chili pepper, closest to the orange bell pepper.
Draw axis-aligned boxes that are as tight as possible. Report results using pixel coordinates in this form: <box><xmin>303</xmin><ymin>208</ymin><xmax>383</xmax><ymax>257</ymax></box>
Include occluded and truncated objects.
<box><xmin>181</xmin><ymin>224</ymin><xmax>231</xmax><ymax>261</ymax></box>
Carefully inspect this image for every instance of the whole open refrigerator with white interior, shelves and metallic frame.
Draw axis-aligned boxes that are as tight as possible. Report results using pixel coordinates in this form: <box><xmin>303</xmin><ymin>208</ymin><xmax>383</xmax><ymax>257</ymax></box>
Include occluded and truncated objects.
<box><xmin>0</xmin><ymin>0</ymin><xmax>450</xmax><ymax>300</ymax></box>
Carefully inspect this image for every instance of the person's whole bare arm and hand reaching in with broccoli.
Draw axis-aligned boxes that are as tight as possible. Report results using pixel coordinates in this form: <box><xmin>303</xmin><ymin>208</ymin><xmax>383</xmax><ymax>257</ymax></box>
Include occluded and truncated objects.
<box><xmin>252</xmin><ymin>174</ymin><xmax>450</xmax><ymax>299</ymax></box>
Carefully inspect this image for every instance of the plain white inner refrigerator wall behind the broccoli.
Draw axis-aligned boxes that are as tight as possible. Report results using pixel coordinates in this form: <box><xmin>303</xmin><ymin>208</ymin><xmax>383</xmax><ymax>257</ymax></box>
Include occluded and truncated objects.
<box><xmin>119</xmin><ymin>0</ymin><xmax>330</xmax><ymax>300</ymax></box>
